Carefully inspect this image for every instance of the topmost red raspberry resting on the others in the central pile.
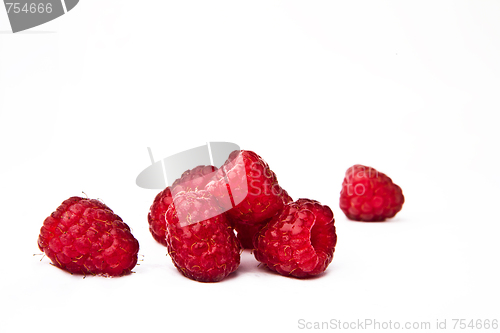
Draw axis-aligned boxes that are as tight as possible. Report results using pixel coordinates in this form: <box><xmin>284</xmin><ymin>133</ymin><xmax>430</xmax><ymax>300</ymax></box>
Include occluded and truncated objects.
<box><xmin>205</xmin><ymin>150</ymin><xmax>286</xmax><ymax>224</ymax></box>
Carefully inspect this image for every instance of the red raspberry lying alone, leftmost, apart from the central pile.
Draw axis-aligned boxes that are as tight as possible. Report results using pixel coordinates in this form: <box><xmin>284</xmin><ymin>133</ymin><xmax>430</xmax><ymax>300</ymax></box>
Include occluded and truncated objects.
<box><xmin>38</xmin><ymin>197</ymin><xmax>139</xmax><ymax>276</ymax></box>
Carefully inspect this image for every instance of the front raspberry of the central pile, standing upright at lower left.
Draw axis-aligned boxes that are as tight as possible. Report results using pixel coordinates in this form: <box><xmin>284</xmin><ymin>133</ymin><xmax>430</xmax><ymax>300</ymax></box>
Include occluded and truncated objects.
<box><xmin>167</xmin><ymin>190</ymin><xmax>240</xmax><ymax>282</ymax></box>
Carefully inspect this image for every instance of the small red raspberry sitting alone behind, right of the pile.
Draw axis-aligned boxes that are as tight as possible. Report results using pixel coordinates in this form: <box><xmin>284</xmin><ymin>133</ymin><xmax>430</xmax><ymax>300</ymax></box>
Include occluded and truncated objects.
<box><xmin>340</xmin><ymin>164</ymin><xmax>405</xmax><ymax>222</ymax></box>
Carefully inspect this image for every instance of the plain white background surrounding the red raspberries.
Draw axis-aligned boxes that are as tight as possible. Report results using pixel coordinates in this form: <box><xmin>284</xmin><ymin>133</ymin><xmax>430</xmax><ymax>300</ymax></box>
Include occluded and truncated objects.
<box><xmin>0</xmin><ymin>0</ymin><xmax>500</xmax><ymax>332</ymax></box>
